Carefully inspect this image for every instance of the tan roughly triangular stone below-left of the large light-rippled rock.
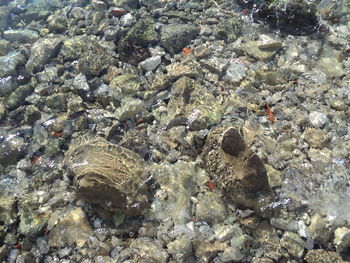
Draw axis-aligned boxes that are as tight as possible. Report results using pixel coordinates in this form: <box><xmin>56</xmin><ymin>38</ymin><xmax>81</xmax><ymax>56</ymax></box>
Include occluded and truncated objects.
<box><xmin>48</xmin><ymin>207</ymin><xmax>93</xmax><ymax>250</ymax></box>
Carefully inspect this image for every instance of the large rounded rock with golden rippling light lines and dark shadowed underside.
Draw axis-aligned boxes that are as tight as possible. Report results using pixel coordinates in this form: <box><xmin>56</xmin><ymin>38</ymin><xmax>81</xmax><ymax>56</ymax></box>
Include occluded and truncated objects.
<box><xmin>64</xmin><ymin>136</ymin><xmax>148</xmax><ymax>215</ymax></box>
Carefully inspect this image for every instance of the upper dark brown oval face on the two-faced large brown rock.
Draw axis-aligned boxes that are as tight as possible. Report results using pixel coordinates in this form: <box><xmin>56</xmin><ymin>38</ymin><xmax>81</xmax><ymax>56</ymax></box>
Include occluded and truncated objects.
<box><xmin>221</xmin><ymin>128</ymin><xmax>245</xmax><ymax>157</ymax></box>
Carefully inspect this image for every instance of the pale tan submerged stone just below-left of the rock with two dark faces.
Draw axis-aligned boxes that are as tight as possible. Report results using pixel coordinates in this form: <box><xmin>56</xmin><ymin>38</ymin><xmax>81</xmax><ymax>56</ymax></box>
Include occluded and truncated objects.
<box><xmin>196</xmin><ymin>192</ymin><xmax>227</xmax><ymax>224</ymax></box>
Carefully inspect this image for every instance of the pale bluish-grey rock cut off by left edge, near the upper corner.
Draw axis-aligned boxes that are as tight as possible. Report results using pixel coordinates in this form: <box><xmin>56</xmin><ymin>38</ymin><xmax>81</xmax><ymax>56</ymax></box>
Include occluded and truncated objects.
<box><xmin>0</xmin><ymin>51</ymin><xmax>26</xmax><ymax>78</ymax></box>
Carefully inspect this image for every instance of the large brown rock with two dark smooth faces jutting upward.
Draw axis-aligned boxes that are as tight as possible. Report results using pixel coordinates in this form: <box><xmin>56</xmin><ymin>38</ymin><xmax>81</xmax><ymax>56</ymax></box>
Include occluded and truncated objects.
<box><xmin>202</xmin><ymin>127</ymin><xmax>274</xmax><ymax>216</ymax></box>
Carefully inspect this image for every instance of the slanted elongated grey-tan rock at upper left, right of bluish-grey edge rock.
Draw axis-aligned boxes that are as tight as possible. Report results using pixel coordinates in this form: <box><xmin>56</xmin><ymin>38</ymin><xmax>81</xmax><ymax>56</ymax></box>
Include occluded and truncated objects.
<box><xmin>26</xmin><ymin>38</ymin><xmax>62</xmax><ymax>73</ymax></box>
